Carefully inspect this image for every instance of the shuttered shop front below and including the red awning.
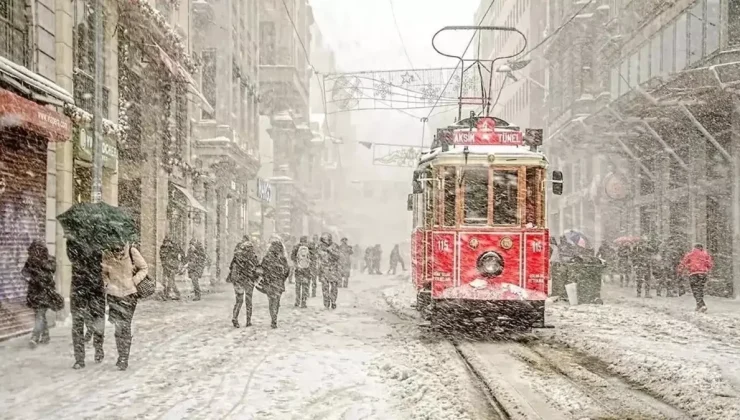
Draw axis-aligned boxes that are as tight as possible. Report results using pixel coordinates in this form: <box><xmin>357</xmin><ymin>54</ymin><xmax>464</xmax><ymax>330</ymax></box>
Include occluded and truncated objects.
<box><xmin>0</xmin><ymin>89</ymin><xmax>72</xmax><ymax>340</ymax></box>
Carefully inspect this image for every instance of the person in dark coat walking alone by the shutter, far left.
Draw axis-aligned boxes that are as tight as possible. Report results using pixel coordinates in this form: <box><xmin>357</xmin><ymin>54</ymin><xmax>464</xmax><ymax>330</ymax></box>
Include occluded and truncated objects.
<box><xmin>21</xmin><ymin>241</ymin><xmax>56</xmax><ymax>348</ymax></box>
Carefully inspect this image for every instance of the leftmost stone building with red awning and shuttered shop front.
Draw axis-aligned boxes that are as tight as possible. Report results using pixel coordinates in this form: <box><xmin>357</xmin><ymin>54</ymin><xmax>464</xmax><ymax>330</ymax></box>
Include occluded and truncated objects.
<box><xmin>0</xmin><ymin>0</ymin><xmax>77</xmax><ymax>339</ymax></box>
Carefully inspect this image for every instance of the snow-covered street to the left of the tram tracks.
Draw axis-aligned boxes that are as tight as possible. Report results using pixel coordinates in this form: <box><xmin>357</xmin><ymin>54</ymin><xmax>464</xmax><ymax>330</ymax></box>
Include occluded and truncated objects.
<box><xmin>0</xmin><ymin>276</ymin><xmax>490</xmax><ymax>420</ymax></box>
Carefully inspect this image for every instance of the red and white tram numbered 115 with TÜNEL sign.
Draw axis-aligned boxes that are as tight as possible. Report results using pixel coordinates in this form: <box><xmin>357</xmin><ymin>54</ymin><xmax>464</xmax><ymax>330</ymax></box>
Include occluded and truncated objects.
<box><xmin>408</xmin><ymin>116</ymin><xmax>562</xmax><ymax>328</ymax></box>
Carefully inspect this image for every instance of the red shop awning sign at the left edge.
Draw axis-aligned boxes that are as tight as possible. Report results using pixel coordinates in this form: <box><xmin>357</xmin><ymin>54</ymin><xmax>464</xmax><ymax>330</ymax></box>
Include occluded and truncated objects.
<box><xmin>0</xmin><ymin>89</ymin><xmax>72</xmax><ymax>141</ymax></box>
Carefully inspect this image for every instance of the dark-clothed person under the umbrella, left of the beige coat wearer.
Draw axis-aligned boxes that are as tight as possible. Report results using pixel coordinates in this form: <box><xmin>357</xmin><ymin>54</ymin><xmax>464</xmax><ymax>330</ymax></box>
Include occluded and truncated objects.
<box><xmin>67</xmin><ymin>236</ymin><xmax>105</xmax><ymax>369</ymax></box>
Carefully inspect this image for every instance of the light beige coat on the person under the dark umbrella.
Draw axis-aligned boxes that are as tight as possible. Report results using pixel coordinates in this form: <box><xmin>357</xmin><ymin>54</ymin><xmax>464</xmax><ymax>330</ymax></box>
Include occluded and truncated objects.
<box><xmin>103</xmin><ymin>244</ymin><xmax>149</xmax><ymax>297</ymax></box>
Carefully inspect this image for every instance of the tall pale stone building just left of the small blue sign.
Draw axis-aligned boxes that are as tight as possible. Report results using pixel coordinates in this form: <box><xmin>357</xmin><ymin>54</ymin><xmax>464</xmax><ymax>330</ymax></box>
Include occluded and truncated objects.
<box><xmin>191</xmin><ymin>0</ymin><xmax>260</xmax><ymax>277</ymax></box>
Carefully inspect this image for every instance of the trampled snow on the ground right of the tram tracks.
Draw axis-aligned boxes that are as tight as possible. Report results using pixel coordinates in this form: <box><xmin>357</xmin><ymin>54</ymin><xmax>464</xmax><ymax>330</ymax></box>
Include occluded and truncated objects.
<box><xmin>541</xmin><ymin>288</ymin><xmax>740</xmax><ymax>420</ymax></box>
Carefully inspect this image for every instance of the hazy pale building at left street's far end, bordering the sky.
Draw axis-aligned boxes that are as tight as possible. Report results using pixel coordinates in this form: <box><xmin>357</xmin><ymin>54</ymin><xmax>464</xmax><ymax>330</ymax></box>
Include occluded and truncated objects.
<box><xmin>259</xmin><ymin>0</ymin><xmax>315</xmax><ymax>236</ymax></box>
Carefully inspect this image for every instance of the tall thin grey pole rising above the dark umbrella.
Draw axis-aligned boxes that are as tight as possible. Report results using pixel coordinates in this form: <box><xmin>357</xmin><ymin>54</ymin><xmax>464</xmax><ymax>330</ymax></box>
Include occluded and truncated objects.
<box><xmin>91</xmin><ymin>0</ymin><xmax>107</xmax><ymax>203</ymax></box>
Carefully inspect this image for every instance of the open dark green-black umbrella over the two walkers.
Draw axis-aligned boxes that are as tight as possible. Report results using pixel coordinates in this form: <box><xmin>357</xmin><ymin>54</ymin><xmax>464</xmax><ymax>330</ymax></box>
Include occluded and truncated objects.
<box><xmin>57</xmin><ymin>202</ymin><xmax>138</xmax><ymax>250</ymax></box>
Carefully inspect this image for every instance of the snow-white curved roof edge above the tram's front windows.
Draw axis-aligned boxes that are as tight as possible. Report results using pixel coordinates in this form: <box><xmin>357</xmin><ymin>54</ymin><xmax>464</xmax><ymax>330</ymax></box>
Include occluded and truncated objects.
<box><xmin>419</xmin><ymin>146</ymin><xmax>547</xmax><ymax>166</ymax></box>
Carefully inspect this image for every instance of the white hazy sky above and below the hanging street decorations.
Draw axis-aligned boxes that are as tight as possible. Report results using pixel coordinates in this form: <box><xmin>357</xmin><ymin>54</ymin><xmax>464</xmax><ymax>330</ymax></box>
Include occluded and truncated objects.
<box><xmin>310</xmin><ymin>0</ymin><xmax>480</xmax><ymax>151</ymax></box>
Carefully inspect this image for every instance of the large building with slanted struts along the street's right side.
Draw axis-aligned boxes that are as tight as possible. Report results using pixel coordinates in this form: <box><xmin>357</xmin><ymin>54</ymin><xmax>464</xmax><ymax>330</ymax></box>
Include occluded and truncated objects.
<box><xmin>545</xmin><ymin>0</ymin><xmax>740</xmax><ymax>295</ymax></box>
